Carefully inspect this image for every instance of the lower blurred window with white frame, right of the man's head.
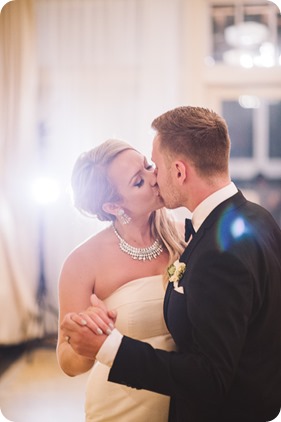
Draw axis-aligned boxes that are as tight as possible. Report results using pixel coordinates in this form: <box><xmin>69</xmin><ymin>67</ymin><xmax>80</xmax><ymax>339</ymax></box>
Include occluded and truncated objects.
<box><xmin>221</xmin><ymin>95</ymin><xmax>281</xmax><ymax>180</ymax></box>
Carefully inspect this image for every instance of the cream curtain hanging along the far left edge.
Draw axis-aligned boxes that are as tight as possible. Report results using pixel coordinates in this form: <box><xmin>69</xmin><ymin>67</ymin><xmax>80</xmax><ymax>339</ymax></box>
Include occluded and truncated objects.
<box><xmin>0</xmin><ymin>0</ymin><xmax>42</xmax><ymax>344</ymax></box>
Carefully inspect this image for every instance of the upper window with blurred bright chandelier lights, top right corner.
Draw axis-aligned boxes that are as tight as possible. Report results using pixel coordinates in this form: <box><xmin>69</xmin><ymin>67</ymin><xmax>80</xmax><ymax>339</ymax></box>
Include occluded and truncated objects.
<box><xmin>211</xmin><ymin>2</ymin><xmax>281</xmax><ymax>68</ymax></box>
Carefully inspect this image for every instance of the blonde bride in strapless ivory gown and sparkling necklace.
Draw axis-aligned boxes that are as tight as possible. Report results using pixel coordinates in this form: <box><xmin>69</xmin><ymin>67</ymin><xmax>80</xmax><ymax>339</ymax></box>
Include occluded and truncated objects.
<box><xmin>57</xmin><ymin>140</ymin><xmax>184</xmax><ymax>422</ymax></box>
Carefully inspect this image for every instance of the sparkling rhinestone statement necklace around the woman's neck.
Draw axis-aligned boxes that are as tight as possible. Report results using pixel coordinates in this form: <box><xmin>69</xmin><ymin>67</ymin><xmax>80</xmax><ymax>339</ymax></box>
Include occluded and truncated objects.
<box><xmin>112</xmin><ymin>224</ymin><xmax>163</xmax><ymax>261</ymax></box>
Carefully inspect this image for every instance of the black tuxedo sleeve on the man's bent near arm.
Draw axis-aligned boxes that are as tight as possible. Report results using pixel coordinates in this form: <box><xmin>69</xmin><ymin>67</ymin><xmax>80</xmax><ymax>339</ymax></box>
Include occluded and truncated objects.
<box><xmin>106</xmin><ymin>252</ymin><xmax>253</xmax><ymax>402</ymax></box>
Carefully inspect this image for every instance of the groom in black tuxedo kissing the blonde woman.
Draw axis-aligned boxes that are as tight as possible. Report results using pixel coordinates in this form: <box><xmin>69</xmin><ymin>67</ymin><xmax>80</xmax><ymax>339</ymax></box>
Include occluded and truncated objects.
<box><xmin>65</xmin><ymin>107</ymin><xmax>281</xmax><ymax>422</ymax></box>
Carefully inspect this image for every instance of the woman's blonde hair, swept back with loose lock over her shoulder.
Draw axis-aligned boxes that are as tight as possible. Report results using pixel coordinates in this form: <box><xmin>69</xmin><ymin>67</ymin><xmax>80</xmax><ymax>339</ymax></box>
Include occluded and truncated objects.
<box><xmin>71</xmin><ymin>139</ymin><xmax>185</xmax><ymax>282</ymax></box>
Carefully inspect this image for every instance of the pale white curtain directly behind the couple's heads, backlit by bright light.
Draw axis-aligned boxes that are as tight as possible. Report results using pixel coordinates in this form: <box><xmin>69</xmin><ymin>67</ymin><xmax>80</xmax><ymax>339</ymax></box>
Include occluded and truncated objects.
<box><xmin>36</xmin><ymin>0</ymin><xmax>184</xmax><ymax>303</ymax></box>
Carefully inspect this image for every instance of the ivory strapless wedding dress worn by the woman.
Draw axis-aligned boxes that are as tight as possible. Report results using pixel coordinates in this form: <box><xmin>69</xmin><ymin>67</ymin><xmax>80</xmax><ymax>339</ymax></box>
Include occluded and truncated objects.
<box><xmin>85</xmin><ymin>275</ymin><xmax>175</xmax><ymax>422</ymax></box>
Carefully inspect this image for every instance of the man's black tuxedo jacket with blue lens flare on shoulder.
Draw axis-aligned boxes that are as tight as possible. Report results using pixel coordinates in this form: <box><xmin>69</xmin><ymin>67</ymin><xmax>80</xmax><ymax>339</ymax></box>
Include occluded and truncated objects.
<box><xmin>109</xmin><ymin>192</ymin><xmax>281</xmax><ymax>422</ymax></box>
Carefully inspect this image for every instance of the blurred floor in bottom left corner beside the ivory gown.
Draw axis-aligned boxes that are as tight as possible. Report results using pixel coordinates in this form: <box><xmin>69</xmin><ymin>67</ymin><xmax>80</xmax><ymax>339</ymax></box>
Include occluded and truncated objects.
<box><xmin>0</xmin><ymin>338</ymin><xmax>88</xmax><ymax>422</ymax></box>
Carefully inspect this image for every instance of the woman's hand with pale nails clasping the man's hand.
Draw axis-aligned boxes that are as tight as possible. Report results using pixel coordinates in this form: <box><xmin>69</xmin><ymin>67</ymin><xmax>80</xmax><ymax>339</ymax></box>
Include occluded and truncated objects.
<box><xmin>71</xmin><ymin>294</ymin><xmax>117</xmax><ymax>335</ymax></box>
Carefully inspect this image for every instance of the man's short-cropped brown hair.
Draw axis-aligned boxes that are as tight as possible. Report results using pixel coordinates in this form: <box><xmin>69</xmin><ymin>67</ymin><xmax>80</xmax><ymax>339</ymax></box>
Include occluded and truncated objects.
<box><xmin>151</xmin><ymin>106</ymin><xmax>230</xmax><ymax>176</ymax></box>
